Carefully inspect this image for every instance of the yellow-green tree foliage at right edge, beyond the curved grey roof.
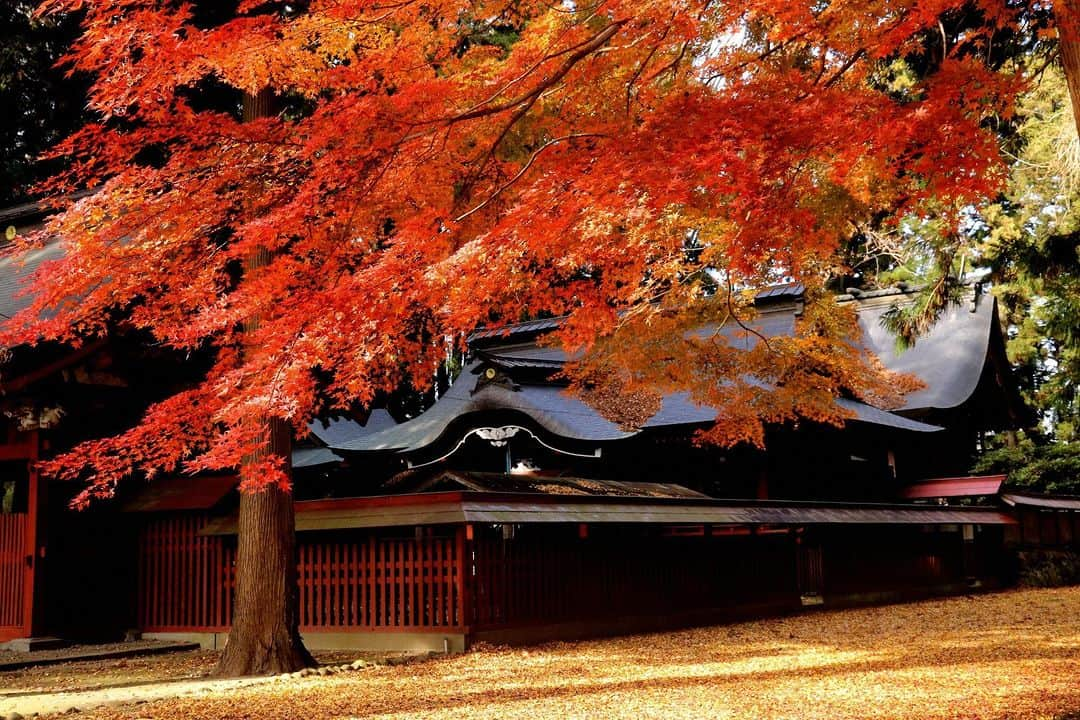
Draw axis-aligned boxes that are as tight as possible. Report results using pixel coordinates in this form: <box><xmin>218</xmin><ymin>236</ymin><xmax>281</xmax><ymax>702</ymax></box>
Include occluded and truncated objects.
<box><xmin>820</xmin><ymin>12</ymin><xmax>1080</xmax><ymax>492</ymax></box>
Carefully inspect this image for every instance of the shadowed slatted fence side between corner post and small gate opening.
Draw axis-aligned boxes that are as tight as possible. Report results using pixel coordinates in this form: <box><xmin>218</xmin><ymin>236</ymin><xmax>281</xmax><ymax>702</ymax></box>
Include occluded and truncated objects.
<box><xmin>470</xmin><ymin>527</ymin><xmax>797</xmax><ymax>630</ymax></box>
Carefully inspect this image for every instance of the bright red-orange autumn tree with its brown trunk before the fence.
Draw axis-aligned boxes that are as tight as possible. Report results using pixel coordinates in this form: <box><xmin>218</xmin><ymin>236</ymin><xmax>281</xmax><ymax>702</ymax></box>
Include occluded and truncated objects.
<box><xmin>0</xmin><ymin>0</ymin><xmax>1045</xmax><ymax>674</ymax></box>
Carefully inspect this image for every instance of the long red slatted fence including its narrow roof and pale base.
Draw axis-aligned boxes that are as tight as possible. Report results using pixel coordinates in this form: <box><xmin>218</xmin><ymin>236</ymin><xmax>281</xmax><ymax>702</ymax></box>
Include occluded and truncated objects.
<box><xmin>130</xmin><ymin>492</ymin><xmax>1012</xmax><ymax>650</ymax></box>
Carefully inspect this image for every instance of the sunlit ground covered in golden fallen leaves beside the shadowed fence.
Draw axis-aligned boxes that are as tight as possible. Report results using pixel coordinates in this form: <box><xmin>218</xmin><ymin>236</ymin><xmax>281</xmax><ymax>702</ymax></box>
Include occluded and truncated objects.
<box><xmin>27</xmin><ymin>587</ymin><xmax>1080</xmax><ymax>720</ymax></box>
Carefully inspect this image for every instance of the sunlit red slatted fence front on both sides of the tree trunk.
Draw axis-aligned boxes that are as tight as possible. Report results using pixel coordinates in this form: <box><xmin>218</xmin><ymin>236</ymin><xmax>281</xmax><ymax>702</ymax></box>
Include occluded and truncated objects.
<box><xmin>138</xmin><ymin>514</ymin><xmax>463</xmax><ymax>633</ymax></box>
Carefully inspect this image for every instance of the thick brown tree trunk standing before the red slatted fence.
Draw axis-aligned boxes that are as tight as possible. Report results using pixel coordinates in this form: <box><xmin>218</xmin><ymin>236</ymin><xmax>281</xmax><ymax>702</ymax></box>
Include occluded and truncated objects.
<box><xmin>215</xmin><ymin>91</ymin><xmax>314</xmax><ymax>677</ymax></box>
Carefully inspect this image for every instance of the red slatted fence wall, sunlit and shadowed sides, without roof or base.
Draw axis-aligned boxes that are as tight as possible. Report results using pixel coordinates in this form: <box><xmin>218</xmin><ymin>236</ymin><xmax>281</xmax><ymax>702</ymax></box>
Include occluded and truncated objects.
<box><xmin>138</xmin><ymin>515</ymin><xmax>1000</xmax><ymax>633</ymax></box>
